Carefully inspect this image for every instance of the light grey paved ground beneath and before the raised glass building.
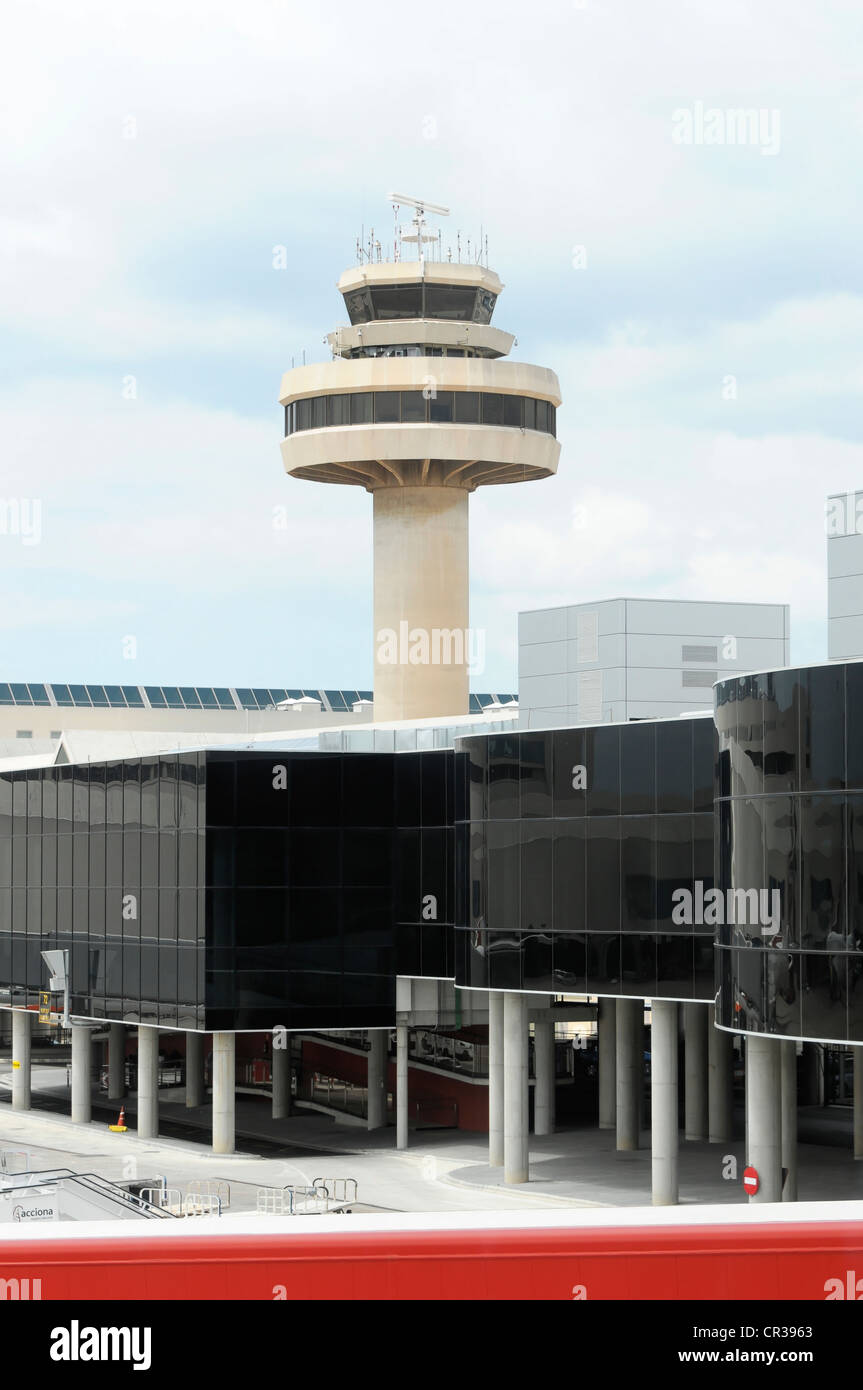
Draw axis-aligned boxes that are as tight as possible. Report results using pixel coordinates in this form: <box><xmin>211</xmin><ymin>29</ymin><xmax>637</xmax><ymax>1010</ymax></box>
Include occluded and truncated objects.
<box><xmin>0</xmin><ymin>1062</ymin><xmax>863</xmax><ymax>1212</ymax></box>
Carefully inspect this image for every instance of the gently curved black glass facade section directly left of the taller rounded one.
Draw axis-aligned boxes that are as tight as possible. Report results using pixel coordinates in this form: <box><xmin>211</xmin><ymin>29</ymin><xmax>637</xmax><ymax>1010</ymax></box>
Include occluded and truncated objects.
<box><xmin>454</xmin><ymin>719</ymin><xmax>714</xmax><ymax>999</ymax></box>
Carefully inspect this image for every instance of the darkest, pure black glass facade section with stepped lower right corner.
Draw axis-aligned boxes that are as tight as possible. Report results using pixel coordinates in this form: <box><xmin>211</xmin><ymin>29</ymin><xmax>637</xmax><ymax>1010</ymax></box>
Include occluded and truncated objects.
<box><xmin>206</xmin><ymin>752</ymin><xmax>454</xmax><ymax>1030</ymax></box>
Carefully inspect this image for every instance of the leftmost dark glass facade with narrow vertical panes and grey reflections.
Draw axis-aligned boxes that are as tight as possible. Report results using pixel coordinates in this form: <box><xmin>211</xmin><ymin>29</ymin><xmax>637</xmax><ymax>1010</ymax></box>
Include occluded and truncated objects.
<box><xmin>0</xmin><ymin>753</ymin><xmax>204</xmax><ymax>1029</ymax></box>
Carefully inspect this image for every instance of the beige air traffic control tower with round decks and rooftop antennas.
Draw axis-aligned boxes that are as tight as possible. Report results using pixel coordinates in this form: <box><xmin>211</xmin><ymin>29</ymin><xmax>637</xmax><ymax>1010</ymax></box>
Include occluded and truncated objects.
<box><xmin>279</xmin><ymin>201</ymin><xmax>560</xmax><ymax>720</ymax></box>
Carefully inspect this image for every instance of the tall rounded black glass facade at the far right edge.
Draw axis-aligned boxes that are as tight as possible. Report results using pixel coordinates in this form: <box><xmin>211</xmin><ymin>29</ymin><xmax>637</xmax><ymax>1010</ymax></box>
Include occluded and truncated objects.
<box><xmin>716</xmin><ymin>662</ymin><xmax>863</xmax><ymax>1043</ymax></box>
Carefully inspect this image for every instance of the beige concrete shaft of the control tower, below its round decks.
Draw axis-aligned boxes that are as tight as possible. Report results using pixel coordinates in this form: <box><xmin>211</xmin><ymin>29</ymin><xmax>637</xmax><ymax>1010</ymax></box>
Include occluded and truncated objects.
<box><xmin>374</xmin><ymin>485</ymin><xmax>471</xmax><ymax>720</ymax></box>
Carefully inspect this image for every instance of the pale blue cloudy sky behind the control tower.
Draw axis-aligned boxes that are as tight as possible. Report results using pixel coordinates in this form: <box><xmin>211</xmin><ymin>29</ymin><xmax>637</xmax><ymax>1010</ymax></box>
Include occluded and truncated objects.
<box><xmin>0</xmin><ymin>0</ymin><xmax>863</xmax><ymax>689</ymax></box>
